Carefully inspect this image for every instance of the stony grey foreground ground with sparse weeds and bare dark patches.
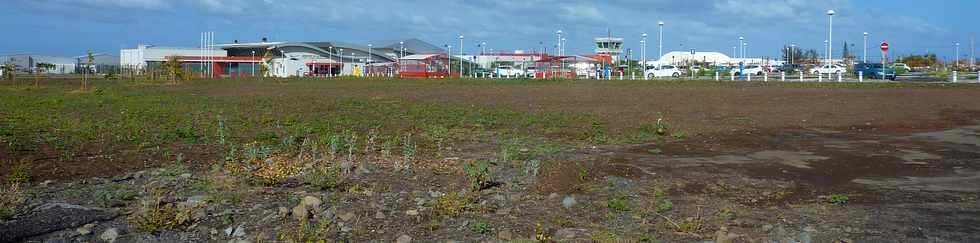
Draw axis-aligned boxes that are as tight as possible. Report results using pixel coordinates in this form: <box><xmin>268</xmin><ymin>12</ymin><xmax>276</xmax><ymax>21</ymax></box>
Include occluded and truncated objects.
<box><xmin>0</xmin><ymin>123</ymin><xmax>980</xmax><ymax>242</ymax></box>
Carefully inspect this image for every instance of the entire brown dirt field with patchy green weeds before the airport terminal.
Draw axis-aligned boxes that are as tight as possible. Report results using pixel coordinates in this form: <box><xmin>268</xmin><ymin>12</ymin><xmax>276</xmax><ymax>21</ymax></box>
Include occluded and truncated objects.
<box><xmin>0</xmin><ymin>79</ymin><xmax>980</xmax><ymax>242</ymax></box>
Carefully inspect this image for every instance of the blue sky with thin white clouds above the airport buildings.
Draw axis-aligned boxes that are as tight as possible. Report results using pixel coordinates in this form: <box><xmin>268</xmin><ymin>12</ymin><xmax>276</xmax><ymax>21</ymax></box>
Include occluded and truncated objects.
<box><xmin>0</xmin><ymin>0</ymin><xmax>980</xmax><ymax>59</ymax></box>
